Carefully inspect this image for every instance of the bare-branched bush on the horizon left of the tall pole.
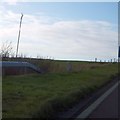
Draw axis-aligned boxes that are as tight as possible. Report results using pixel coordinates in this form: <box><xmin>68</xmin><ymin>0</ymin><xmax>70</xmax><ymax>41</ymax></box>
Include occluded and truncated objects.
<box><xmin>0</xmin><ymin>41</ymin><xmax>13</xmax><ymax>58</ymax></box>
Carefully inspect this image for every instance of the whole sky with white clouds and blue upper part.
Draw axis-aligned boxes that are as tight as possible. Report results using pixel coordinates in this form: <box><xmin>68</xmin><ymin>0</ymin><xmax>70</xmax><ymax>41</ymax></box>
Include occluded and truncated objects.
<box><xmin>0</xmin><ymin>0</ymin><xmax>118</xmax><ymax>60</ymax></box>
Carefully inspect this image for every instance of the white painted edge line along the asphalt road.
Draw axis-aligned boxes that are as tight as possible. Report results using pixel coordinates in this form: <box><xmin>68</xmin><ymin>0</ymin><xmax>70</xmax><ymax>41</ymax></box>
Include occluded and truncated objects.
<box><xmin>76</xmin><ymin>81</ymin><xmax>120</xmax><ymax>120</ymax></box>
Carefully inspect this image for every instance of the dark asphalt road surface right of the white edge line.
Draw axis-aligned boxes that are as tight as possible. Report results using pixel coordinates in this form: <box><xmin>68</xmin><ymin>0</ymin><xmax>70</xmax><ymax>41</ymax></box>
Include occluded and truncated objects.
<box><xmin>89</xmin><ymin>82</ymin><xmax>120</xmax><ymax>118</ymax></box>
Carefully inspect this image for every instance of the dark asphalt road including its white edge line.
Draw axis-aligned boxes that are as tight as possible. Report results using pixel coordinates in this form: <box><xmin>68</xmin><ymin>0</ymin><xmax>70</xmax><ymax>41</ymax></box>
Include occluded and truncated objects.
<box><xmin>76</xmin><ymin>82</ymin><xmax>120</xmax><ymax>120</ymax></box>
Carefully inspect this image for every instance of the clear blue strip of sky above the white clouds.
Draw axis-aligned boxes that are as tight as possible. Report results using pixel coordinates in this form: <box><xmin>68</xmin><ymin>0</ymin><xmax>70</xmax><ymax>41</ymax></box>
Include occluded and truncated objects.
<box><xmin>2</xmin><ymin>2</ymin><xmax>118</xmax><ymax>24</ymax></box>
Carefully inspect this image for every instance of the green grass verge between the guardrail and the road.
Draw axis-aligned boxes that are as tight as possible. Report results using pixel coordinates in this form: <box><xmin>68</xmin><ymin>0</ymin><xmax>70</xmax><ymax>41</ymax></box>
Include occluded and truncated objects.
<box><xmin>2</xmin><ymin>63</ymin><xmax>118</xmax><ymax>119</ymax></box>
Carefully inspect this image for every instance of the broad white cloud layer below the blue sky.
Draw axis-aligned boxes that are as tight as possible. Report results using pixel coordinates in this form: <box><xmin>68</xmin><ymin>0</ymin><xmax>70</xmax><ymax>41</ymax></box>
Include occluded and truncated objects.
<box><xmin>0</xmin><ymin>11</ymin><xmax>118</xmax><ymax>59</ymax></box>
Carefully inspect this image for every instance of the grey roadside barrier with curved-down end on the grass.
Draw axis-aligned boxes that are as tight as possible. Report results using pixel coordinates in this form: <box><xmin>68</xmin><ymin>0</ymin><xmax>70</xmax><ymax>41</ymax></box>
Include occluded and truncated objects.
<box><xmin>0</xmin><ymin>61</ymin><xmax>42</xmax><ymax>76</ymax></box>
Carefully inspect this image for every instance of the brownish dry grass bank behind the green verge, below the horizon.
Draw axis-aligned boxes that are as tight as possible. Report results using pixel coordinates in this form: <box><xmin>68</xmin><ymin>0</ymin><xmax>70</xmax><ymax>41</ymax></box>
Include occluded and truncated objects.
<box><xmin>3</xmin><ymin>58</ymin><xmax>111</xmax><ymax>73</ymax></box>
